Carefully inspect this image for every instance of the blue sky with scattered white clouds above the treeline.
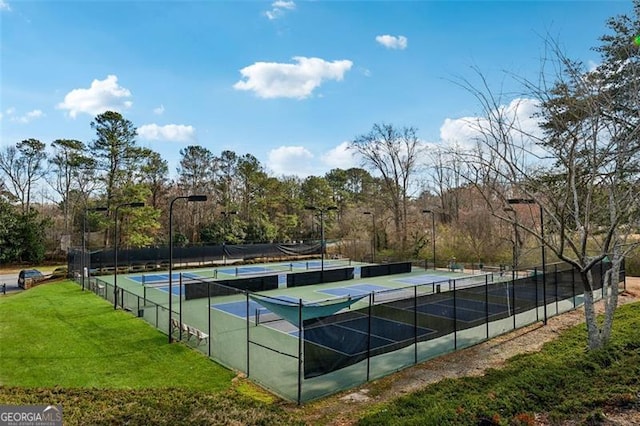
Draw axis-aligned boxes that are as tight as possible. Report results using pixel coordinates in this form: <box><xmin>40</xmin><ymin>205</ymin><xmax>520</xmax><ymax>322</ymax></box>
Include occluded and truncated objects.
<box><xmin>0</xmin><ymin>0</ymin><xmax>632</xmax><ymax>177</ymax></box>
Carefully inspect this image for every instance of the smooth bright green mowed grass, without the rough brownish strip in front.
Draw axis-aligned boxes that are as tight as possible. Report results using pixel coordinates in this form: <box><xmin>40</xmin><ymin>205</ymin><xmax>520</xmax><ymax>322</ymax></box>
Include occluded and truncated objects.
<box><xmin>0</xmin><ymin>281</ymin><xmax>234</xmax><ymax>391</ymax></box>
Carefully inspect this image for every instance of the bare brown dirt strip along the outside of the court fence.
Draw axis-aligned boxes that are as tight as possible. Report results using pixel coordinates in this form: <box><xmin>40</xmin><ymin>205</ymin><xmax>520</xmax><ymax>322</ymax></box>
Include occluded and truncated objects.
<box><xmin>293</xmin><ymin>277</ymin><xmax>640</xmax><ymax>426</ymax></box>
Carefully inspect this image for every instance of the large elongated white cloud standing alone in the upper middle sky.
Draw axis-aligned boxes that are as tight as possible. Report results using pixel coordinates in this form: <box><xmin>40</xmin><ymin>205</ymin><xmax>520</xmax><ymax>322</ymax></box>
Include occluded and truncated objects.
<box><xmin>233</xmin><ymin>56</ymin><xmax>353</xmax><ymax>99</ymax></box>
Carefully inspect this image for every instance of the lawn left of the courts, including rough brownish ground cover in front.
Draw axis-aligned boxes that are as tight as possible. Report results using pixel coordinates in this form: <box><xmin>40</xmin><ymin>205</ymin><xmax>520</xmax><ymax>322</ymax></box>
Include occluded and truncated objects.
<box><xmin>0</xmin><ymin>281</ymin><xmax>300</xmax><ymax>425</ymax></box>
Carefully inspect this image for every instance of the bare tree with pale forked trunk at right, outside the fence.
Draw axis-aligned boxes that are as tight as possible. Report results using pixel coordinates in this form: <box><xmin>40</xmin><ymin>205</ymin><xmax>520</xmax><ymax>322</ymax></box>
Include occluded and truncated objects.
<box><xmin>456</xmin><ymin>16</ymin><xmax>640</xmax><ymax>348</ymax></box>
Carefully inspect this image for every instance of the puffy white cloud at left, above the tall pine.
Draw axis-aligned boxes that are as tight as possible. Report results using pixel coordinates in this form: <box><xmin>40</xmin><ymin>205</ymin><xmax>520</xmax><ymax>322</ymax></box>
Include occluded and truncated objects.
<box><xmin>57</xmin><ymin>75</ymin><xmax>132</xmax><ymax>118</ymax></box>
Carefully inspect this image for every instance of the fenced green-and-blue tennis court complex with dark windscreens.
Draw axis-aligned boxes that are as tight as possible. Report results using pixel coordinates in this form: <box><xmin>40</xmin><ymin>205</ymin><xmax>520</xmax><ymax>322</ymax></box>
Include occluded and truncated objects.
<box><xmin>82</xmin><ymin>261</ymin><xmax>624</xmax><ymax>402</ymax></box>
